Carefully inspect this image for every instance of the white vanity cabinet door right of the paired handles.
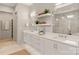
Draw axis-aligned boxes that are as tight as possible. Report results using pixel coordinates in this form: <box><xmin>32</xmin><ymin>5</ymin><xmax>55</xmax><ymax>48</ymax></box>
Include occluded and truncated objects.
<box><xmin>57</xmin><ymin>42</ymin><xmax>76</xmax><ymax>55</ymax></box>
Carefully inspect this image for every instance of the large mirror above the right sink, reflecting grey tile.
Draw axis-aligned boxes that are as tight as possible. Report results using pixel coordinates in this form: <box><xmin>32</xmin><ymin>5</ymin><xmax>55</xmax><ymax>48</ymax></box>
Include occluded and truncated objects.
<box><xmin>53</xmin><ymin>11</ymin><xmax>79</xmax><ymax>34</ymax></box>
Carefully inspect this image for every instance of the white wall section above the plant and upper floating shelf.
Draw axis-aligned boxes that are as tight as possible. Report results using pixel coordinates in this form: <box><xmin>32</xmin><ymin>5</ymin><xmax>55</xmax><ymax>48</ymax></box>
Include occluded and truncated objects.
<box><xmin>32</xmin><ymin>3</ymin><xmax>55</xmax><ymax>13</ymax></box>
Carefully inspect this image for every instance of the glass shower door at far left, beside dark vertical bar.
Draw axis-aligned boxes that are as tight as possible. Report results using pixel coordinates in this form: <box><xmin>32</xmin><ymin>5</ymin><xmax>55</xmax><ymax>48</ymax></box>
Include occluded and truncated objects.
<box><xmin>0</xmin><ymin>20</ymin><xmax>12</xmax><ymax>40</ymax></box>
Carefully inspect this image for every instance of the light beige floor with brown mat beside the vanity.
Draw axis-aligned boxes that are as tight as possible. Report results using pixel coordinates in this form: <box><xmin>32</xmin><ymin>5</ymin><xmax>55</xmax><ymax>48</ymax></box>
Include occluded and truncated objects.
<box><xmin>0</xmin><ymin>39</ymin><xmax>29</xmax><ymax>55</ymax></box>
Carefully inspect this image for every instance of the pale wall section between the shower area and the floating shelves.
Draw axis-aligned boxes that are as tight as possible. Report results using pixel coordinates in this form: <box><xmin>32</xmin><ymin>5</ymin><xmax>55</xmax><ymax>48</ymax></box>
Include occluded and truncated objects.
<box><xmin>16</xmin><ymin>4</ymin><xmax>30</xmax><ymax>43</ymax></box>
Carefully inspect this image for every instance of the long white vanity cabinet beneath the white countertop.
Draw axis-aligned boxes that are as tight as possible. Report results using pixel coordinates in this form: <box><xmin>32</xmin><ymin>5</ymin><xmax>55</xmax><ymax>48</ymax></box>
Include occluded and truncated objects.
<box><xmin>24</xmin><ymin>33</ymin><xmax>76</xmax><ymax>55</ymax></box>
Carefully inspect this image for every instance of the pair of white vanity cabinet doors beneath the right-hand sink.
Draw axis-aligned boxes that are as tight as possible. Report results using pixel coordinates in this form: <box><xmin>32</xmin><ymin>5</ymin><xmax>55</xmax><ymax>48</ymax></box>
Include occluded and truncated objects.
<box><xmin>40</xmin><ymin>38</ymin><xmax>76</xmax><ymax>55</ymax></box>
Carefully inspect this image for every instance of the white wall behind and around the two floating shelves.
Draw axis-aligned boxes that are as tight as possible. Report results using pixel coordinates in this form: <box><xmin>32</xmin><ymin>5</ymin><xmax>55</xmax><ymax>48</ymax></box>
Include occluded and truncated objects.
<box><xmin>31</xmin><ymin>3</ymin><xmax>55</xmax><ymax>32</ymax></box>
